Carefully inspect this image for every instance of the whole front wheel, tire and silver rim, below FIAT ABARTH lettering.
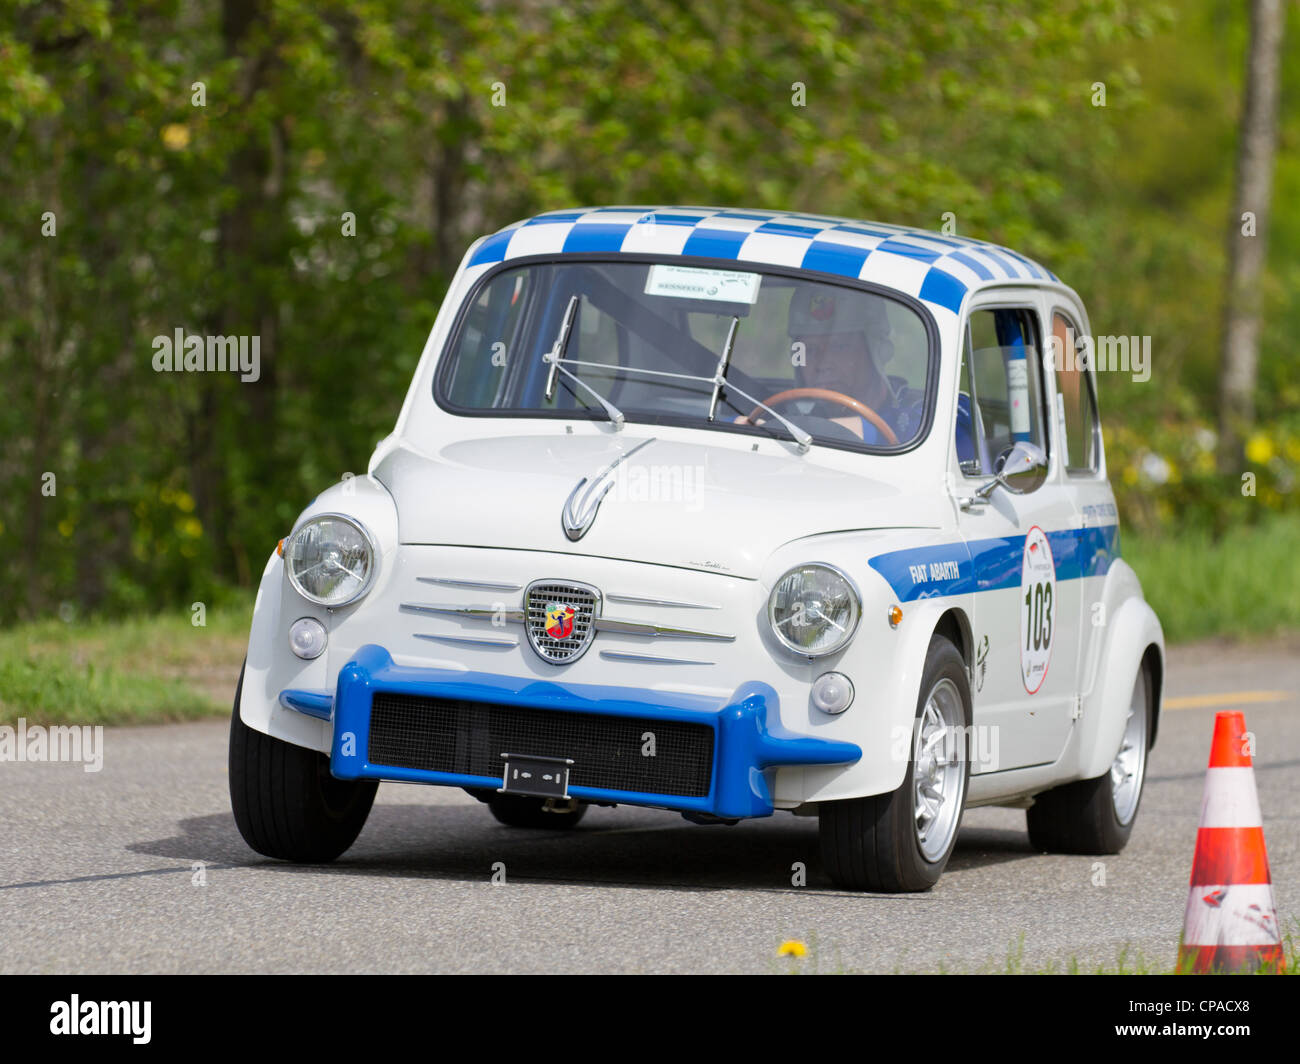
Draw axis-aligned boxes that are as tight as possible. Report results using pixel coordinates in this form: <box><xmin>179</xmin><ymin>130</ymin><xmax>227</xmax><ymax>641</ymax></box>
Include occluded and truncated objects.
<box><xmin>818</xmin><ymin>636</ymin><xmax>971</xmax><ymax>892</ymax></box>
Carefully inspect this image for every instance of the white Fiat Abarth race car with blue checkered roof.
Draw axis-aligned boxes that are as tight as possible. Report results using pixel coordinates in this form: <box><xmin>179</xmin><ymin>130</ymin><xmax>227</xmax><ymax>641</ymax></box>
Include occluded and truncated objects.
<box><xmin>230</xmin><ymin>207</ymin><xmax>1165</xmax><ymax>891</ymax></box>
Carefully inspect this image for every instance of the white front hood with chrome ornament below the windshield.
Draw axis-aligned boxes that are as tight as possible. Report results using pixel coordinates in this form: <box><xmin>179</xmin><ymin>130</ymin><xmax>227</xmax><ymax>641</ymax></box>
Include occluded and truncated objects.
<box><xmin>374</xmin><ymin>432</ymin><xmax>941</xmax><ymax>579</ymax></box>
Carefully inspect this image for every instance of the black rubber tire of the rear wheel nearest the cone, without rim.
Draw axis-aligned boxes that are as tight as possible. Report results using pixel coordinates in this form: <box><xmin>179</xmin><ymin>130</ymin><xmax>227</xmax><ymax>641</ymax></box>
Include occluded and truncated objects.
<box><xmin>1024</xmin><ymin>665</ymin><xmax>1152</xmax><ymax>856</ymax></box>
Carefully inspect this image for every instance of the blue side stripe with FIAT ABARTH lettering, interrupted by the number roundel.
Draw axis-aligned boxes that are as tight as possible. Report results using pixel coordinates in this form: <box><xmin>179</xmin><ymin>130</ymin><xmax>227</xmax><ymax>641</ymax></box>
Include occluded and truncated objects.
<box><xmin>870</xmin><ymin>524</ymin><xmax>1119</xmax><ymax>602</ymax></box>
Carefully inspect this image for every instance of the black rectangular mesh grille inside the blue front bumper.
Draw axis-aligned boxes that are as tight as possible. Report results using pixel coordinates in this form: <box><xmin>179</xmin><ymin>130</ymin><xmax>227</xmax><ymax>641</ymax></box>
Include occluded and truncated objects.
<box><xmin>369</xmin><ymin>692</ymin><xmax>714</xmax><ymax>797</ymax></box>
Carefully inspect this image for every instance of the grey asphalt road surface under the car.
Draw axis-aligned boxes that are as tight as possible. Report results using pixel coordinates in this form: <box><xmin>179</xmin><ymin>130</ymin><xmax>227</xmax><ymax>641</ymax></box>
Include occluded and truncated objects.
<box><xmin>0</xmin><ymin>639</ymin><xmax>1300</xmax><ymax>973</ymax></box>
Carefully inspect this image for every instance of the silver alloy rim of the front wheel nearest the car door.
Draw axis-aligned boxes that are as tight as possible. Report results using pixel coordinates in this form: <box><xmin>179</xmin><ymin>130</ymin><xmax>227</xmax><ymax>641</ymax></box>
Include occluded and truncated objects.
<box><xmin>911</xmin><ymin>678</ymin><xmax>966</xmax><ymax>861</ymax></box>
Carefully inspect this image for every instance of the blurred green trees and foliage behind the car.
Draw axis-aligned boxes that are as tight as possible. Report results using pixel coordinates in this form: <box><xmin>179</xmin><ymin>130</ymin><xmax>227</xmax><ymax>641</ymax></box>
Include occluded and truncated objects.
<box><xmin>0</xmin><ymin>0</ymin><xmax>1300</xmax><ymax>622</ymax></box>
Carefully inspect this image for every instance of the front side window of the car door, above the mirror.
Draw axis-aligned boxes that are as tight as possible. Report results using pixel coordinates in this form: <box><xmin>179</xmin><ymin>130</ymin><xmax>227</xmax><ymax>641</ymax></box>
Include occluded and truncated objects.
<box><xmin>956</xmin><ymin>307</ymin><xmax>1048</xmax><ymax>476</ymax></box>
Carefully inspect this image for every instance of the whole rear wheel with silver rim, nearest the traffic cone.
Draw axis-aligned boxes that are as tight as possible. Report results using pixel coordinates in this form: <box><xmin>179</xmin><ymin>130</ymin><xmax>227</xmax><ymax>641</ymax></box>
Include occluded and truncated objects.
<box><xmin>1026</xmin><ymin>665</ymin><xmax>1152</xmax><ymax>855</ymax></box>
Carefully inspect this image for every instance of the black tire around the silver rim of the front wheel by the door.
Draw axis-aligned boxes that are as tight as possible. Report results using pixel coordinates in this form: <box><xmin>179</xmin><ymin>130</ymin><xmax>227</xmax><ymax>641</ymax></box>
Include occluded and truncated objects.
<box><xmin>818</xmin><ymin>636</ymin><xmax>971</xmax><ymax>894</ymax></box>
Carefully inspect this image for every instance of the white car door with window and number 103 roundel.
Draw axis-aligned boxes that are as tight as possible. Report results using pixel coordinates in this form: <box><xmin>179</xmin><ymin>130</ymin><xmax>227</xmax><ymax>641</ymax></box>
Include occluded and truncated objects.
<box><xmin>949</xmin><ymin>289</ymin><xmax>1082</xmax><ymax>773</ymax></box>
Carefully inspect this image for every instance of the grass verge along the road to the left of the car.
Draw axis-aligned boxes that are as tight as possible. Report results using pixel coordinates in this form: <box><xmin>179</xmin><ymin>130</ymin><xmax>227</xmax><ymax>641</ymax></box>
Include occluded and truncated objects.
<box><xmin>0</xmin><ymin>609</ymin><xmax>248</xmax><ymax>725</ymax></box>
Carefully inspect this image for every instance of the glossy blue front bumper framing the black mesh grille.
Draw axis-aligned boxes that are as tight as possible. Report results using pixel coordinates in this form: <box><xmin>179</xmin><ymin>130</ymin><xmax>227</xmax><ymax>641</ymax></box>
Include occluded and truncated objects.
<box><xmin>280</xmin><ymin>644</ymin><xmax>862</xmax><ymax>818</ymax></box>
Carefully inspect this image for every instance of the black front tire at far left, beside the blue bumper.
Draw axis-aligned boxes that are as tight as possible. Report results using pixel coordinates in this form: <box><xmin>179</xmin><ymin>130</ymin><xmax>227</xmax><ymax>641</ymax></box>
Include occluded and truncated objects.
<box><xmin>230</xmin><ymin>670</ymin><xmax>380</xmax><ymax>864</ymax></box>
